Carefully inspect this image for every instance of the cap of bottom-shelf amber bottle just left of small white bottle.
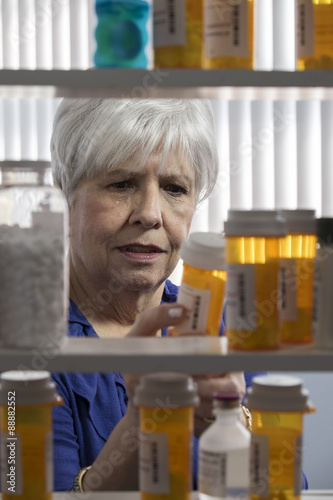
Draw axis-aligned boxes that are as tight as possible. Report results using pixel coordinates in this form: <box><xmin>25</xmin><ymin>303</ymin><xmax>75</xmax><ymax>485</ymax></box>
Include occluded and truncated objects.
<box><xmin>133</xmin><ymin>372</ymin><xmax>199</xmax><ymax>410</ymax></box>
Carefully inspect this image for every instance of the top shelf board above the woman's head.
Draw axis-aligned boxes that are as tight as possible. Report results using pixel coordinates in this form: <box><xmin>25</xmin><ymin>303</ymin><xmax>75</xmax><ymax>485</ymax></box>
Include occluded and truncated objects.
<box><xmin>0</xmin><ymin>68</ymin><xmax>333</xmax><ymax>99</ymax></box>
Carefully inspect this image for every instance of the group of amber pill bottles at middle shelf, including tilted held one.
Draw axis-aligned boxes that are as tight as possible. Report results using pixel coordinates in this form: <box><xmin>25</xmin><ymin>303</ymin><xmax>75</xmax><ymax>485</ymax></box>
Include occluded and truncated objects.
<box><xmin>174</xmin><ymin>210</ymin><xmax>333</xmax><ymax>350</ymax></box>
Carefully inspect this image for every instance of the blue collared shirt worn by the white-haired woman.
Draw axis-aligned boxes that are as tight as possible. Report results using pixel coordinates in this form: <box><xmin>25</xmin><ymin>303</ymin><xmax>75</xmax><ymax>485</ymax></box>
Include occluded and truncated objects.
<box><xmin>52</xmin><ymin>281</ymin><xmax>307</xmax><ymax>491</ymax></box>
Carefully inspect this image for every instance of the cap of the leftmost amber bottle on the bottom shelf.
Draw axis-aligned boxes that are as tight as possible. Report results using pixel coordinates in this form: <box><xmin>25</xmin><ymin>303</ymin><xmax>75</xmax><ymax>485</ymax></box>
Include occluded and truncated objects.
<box><xmin>0</xmin><ymin>370</ymin><xmax>60</xmax><ymax>406</ymax></box>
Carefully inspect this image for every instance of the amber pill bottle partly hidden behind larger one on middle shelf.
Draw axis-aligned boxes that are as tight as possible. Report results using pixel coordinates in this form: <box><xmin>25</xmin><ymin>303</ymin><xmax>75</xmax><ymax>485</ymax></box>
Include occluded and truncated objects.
<box><xmin>280</xmin><ymin>210</ymin><xmax>317</xmax><ymax>344</ymax></box>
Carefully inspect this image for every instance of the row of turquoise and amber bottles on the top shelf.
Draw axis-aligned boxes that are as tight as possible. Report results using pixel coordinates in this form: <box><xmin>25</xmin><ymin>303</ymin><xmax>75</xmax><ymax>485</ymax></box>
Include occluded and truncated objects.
<box><xmin>95</xmin><ymin>0</ymin><xmax>333</xmax><ymax>70</ymax></box>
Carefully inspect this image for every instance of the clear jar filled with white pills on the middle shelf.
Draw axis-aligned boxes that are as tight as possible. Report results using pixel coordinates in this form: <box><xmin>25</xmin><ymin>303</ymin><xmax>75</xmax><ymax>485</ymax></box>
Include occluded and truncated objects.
<box><xmin>0</xmin><ymin>161</ymin><xmax>68</xmax><ymax>353</ymax></box>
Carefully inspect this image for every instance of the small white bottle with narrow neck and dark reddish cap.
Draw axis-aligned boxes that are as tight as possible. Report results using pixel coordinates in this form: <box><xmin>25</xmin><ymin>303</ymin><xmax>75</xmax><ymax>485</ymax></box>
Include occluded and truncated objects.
<box><xmin>198</xmin><ymin>393</ymin><xmax>251</xmax><ymax>500</ymax></box>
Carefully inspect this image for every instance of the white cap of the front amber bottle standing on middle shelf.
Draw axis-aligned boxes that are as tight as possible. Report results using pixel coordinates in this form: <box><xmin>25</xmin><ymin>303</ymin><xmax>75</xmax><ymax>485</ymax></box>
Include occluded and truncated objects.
<box><xmin>224</xmin><ymin>210</ymin><xmax>287</xmax><ymax>236</ymax></box>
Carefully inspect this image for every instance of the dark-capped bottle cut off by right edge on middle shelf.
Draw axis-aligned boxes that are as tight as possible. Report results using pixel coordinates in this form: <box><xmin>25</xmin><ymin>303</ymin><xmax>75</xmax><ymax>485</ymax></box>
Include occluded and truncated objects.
<box><xmin>314</xmin><ymin>217</ymin><xmax>333</xmax><ymax>349</ymax></box>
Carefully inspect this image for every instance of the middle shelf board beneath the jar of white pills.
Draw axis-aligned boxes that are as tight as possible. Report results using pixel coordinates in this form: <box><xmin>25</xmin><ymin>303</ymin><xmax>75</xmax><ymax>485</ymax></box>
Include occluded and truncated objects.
<box><xmin>0</xmin><ymin>337</ymin><xmax>333</xmax><ymax>373</ymax></box>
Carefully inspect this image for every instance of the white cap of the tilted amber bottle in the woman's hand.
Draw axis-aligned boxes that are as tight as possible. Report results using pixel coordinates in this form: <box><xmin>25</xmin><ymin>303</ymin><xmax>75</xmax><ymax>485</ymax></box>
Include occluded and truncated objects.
<box><xmin>179</xmin><ymin>232</ymin><xmax>226</xmax><ymax>271</ymax></box>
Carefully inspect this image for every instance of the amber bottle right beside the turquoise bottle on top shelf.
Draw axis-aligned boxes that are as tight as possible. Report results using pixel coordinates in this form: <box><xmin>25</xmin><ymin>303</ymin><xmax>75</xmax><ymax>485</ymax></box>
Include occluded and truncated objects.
<box><xmin>154</xmin><ymin>0</ymin><xmax>204</xmax><ymax>68</ymax></box>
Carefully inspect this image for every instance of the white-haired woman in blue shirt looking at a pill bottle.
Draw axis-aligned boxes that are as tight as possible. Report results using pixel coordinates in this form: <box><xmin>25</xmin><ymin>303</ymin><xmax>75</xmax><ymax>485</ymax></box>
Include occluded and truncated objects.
<box><xmin>51</xmin><ymin>99</ymin><xmax>306</xmax><ymax>490</ymax></box>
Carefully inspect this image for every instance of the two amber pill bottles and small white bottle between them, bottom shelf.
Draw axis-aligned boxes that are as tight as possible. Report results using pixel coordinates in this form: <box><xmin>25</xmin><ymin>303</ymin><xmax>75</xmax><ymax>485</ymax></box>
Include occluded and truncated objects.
<box><xmin>134</xmin><ymin>373</ymin><xmax>314</xmax><ymax>500</ymax></box>
